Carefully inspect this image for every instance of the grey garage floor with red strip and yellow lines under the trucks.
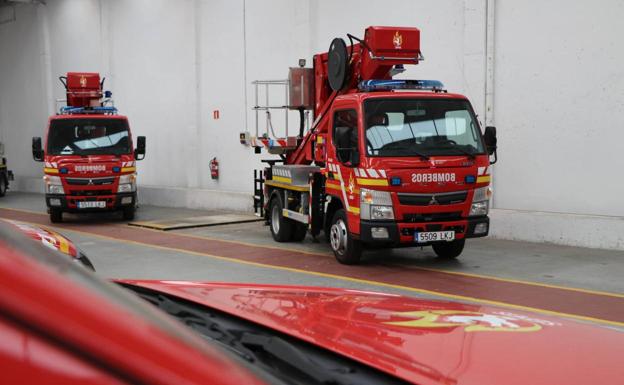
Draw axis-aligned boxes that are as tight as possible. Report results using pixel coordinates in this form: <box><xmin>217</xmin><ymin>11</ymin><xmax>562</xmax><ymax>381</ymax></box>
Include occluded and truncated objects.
<box><xmin>0</xmin><ymin>192</ymin><xmax>624</xmax><ymax>329</ymax></box>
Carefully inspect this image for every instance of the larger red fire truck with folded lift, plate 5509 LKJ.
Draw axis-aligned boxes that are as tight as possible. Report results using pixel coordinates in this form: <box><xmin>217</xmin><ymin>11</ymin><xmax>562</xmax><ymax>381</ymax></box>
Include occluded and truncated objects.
<box><xmin>249</xmin><ymin>27</ymin><xmax>496</xmax><ymax>264</ymax></box>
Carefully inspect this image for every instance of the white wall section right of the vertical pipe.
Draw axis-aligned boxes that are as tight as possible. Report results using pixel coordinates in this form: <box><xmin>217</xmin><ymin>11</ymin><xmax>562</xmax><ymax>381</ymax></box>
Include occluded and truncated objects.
<box><xmin>495</xmin><ymin>0</ymin><xmax>624</xmax><ymax>216</ymax></box>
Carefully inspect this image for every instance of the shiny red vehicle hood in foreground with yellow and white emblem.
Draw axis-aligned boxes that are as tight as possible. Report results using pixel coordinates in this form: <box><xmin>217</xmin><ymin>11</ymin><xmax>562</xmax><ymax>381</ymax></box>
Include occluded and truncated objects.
<box><xmin>119</xmin><ymin>280</ymin><xmax>624</xmax><ymax>385</ymax></box>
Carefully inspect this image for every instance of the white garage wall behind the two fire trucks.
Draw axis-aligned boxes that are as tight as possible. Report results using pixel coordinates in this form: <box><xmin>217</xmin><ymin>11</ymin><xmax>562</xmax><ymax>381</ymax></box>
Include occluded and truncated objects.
<box><xmin>0</xmin><ymin>0</ymin><xmax>624</xmax><ymax>249</ymax></box>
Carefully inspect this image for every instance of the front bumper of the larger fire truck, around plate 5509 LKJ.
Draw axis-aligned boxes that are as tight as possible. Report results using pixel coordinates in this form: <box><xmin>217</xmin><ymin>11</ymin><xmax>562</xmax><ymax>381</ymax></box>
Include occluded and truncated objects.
<box><xmin>359</xmin><ymin>216</ymin><xmax>490</xmax><ymax>246</ymax></box>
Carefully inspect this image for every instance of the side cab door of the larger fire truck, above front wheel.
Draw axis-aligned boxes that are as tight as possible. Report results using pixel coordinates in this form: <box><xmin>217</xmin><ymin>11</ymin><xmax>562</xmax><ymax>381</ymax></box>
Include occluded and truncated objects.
<box><xmin>326</xmin><ymin>107</ymin><xmax>360</xmax><ymax>234</ymax></box>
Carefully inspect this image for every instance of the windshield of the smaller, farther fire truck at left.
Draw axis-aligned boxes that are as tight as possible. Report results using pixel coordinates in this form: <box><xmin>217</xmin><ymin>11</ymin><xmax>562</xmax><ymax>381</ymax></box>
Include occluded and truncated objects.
<box><xmin>47</xmin><ymin>119</ymin><xmax>130</xmax><ymax>155</ymax></box>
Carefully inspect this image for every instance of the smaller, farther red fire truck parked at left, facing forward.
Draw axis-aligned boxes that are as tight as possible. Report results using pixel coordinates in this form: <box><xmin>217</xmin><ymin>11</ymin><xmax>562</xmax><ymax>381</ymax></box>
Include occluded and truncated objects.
<box><xmin>32</xmin><ymin>72</ymin><xmax>145</xmax><ymax>223</ymax></box>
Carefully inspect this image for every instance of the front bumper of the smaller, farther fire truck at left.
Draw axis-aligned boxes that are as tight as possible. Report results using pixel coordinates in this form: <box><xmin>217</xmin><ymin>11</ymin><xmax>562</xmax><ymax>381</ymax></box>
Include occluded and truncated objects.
<box><xmin>45</xmin><ymin>192</ymin><xmax>137</xmax><ymax>213</ymax></box>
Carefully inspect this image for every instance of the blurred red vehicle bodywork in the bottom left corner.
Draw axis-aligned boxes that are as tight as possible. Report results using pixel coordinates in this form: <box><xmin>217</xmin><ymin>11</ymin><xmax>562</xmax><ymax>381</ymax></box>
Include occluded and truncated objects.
<box><xmin>0</xmin><ymin>224</ymin><xmax>262</xmax><ymax>385</ymax></box>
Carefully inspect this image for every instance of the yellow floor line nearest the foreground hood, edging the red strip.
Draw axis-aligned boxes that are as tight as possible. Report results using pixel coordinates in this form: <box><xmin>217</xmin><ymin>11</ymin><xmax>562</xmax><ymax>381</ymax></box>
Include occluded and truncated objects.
<box><xmin>18</xmin><ymin>221</ymin><xmax>624</xmax><ymax>327</ymax></box>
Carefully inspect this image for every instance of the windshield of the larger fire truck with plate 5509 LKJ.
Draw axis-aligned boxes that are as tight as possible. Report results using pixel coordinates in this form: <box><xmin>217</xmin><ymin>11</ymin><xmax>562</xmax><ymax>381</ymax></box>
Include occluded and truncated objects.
<box><xmin>364</xmin><ymin>98</ymin><xmax>484</xmax><ymax>156</ymax></box>
